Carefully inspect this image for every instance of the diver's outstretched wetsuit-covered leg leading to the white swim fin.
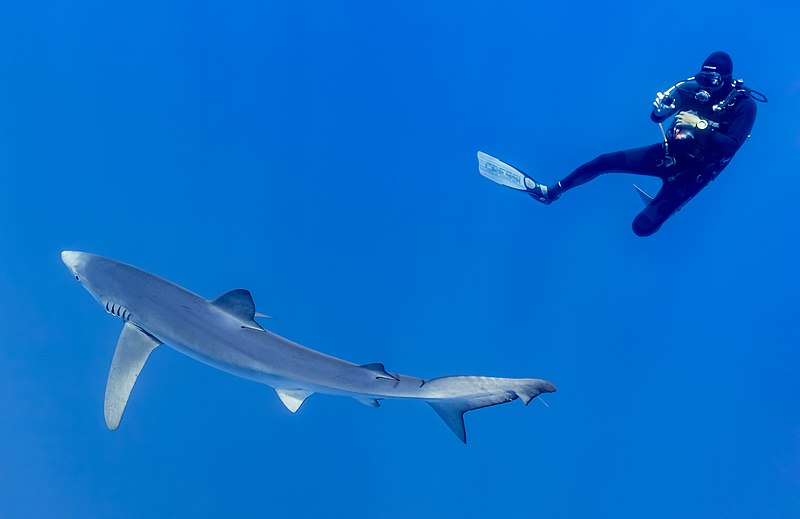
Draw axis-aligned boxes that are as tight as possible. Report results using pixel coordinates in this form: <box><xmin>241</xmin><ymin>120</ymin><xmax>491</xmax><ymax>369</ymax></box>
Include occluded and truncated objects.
<box><xmin>545</xmin><ymin>143</ymin><xmax>668</xmax><ymax>200</ymax></box>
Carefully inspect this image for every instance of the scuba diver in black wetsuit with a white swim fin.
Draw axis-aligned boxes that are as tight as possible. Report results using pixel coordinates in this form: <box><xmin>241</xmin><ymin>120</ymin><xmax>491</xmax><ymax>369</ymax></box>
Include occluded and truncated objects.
<box><xmin>478</xmin><ymin>51</ymin><xmax>767</xmax><ymax>236</ymax></box>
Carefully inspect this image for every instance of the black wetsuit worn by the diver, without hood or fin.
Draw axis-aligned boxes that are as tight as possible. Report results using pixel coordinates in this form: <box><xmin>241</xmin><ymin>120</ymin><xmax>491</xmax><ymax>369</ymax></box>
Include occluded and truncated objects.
<box><xmin>560</xmin><ymin>83</ymin><xmax>756</xmax><ymax>236</ymax></box>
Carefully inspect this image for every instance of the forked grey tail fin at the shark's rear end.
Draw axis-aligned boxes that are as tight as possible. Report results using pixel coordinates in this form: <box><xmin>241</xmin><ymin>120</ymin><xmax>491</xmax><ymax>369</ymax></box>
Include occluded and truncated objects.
<box><xmin>425</xmin><ymin>377</ymin><xmax>556</xmax><ymax>443</ymax></box>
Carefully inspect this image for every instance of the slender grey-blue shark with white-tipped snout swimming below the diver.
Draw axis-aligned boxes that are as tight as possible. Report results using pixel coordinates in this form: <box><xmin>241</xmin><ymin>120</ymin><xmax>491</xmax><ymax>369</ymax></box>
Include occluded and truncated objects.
<box><xmin>61</xmin><ymin>251</ymin><xmax>556</xmax><ymax>443</ymax></box>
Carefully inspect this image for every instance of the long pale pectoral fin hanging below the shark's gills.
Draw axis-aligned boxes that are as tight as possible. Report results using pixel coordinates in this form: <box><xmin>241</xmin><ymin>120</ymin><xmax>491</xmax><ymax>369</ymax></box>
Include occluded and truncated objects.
<box><xmin>104</xmin><ymin>322</ymin><xmax>161</xmax><ymax>431</ymax></box>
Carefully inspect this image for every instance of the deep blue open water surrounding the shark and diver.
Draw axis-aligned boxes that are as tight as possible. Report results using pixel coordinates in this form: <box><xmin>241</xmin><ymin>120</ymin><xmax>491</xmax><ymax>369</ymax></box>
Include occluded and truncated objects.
<box><xmin>0</xmin><ymin>0</ymin><xmax>800</xmax><ymax>518</ymax></box>
